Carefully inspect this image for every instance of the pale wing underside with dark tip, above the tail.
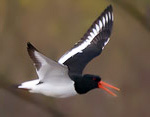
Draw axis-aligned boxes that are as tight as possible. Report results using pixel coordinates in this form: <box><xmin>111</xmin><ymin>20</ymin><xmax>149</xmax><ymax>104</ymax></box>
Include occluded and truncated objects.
<box><xmin>27</xmin><ymin>42</ymin><xmax>67</xmax><ymax>81</ymax></box>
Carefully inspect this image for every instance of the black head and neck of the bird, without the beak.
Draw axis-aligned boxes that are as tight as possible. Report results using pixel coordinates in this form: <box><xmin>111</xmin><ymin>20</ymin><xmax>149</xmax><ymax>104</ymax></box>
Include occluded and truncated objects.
<box><xmin>74</xmin><ymin>74</ymin><xmax>101</xmax><ymax>94</ymax></box>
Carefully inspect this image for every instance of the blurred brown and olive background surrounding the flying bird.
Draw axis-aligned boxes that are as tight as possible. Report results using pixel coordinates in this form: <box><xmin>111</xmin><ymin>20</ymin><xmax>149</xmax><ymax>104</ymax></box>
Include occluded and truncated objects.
<box><xmin>0</xmin><ymin>0</ymin><xmax>150</xmax><ymax>117</ymax></box>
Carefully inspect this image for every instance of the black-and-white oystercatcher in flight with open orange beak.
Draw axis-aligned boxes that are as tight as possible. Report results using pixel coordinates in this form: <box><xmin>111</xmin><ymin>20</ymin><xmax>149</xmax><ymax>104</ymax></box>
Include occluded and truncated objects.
<box><xmin>18</xmin><ymin>5</ymin><xmax>119</xmax><ymax>98</ymax></box>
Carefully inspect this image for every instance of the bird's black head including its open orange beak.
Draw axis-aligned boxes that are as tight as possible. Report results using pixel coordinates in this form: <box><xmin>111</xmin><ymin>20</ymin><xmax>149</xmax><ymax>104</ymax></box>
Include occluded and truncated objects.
<box><xmin>75</xmin><ymin>74</ymin><xmax>120</xmax><ymax>96</ymax></box>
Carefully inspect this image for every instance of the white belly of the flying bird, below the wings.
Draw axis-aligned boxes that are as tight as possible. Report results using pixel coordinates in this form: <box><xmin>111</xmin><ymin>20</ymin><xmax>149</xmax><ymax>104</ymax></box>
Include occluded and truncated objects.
<box><xmin>30</xmin><ymin>80</ymin><xmax>77</xmax><ymax>98</ymax></box>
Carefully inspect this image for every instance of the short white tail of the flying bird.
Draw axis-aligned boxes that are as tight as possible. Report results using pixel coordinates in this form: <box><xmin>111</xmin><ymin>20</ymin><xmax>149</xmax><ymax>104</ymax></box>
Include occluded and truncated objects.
<box><xmin>18</xmin><ymin>79</ymin><xmax>39</xmax><ymax>90</ymax></box>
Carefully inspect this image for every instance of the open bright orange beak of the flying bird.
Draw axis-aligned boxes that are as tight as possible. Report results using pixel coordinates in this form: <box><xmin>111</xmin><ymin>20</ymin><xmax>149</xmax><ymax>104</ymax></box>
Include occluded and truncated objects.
<box><xmin>98</xmin><ymin>81</ymin><xmax>120</xmax><ymax>96</ymax></box>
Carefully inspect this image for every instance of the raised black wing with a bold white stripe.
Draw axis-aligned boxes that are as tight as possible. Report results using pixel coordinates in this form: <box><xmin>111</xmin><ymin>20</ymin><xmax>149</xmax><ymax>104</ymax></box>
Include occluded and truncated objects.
<box><xmin>58</xmin><ymin>5</ymin><xmax>113</xmax><ymax>74</ymax></box>
